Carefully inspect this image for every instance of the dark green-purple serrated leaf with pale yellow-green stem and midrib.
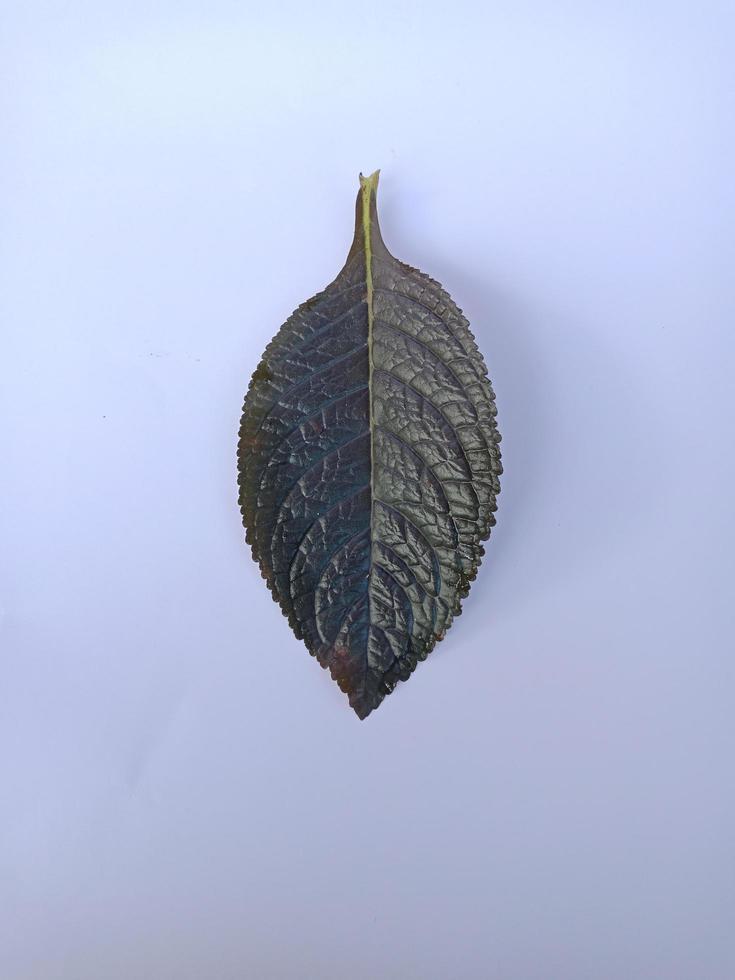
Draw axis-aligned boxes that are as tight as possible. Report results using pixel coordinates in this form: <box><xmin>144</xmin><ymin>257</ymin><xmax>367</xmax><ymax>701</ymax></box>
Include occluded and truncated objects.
<box><xmin>238</xmin><ymin>172</ymin><xmax>502</xmax><ymax>718</ymax></box>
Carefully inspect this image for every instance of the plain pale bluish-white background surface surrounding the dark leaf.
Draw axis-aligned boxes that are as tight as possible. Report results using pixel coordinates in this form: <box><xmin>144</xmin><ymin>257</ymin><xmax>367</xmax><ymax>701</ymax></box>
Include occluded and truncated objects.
<box><xmin>0</xmin><ymin>0</ymin><xmax>735</xmax><ymax>980</ymax></box>
